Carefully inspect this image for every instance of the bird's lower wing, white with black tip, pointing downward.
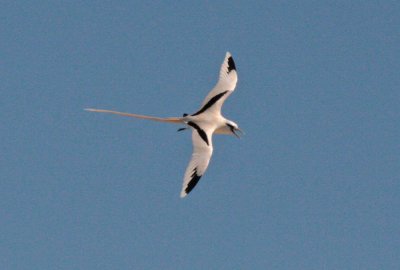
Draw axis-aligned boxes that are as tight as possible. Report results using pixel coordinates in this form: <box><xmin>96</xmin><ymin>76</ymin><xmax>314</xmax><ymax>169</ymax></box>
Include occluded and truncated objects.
<box><xmin>181</xmin><ymin>127</ymin><xmax>213</xmax><ymax>198</ymax></box>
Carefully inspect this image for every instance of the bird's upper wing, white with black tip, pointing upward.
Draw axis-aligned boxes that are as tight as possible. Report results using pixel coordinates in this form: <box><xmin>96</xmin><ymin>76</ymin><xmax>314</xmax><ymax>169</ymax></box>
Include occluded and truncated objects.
<box><xmin>193</xmin><ymin>52</ymin><xmax>238</xmax><ymax>115</ymax></box>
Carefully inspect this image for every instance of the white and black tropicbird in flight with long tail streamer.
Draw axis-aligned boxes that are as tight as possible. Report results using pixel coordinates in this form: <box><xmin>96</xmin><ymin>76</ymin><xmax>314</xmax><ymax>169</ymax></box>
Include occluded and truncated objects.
<box><xmin>85</xmin><ymin>52</ymin><xmax>243</xmax><ymax>198</ymax></box>
